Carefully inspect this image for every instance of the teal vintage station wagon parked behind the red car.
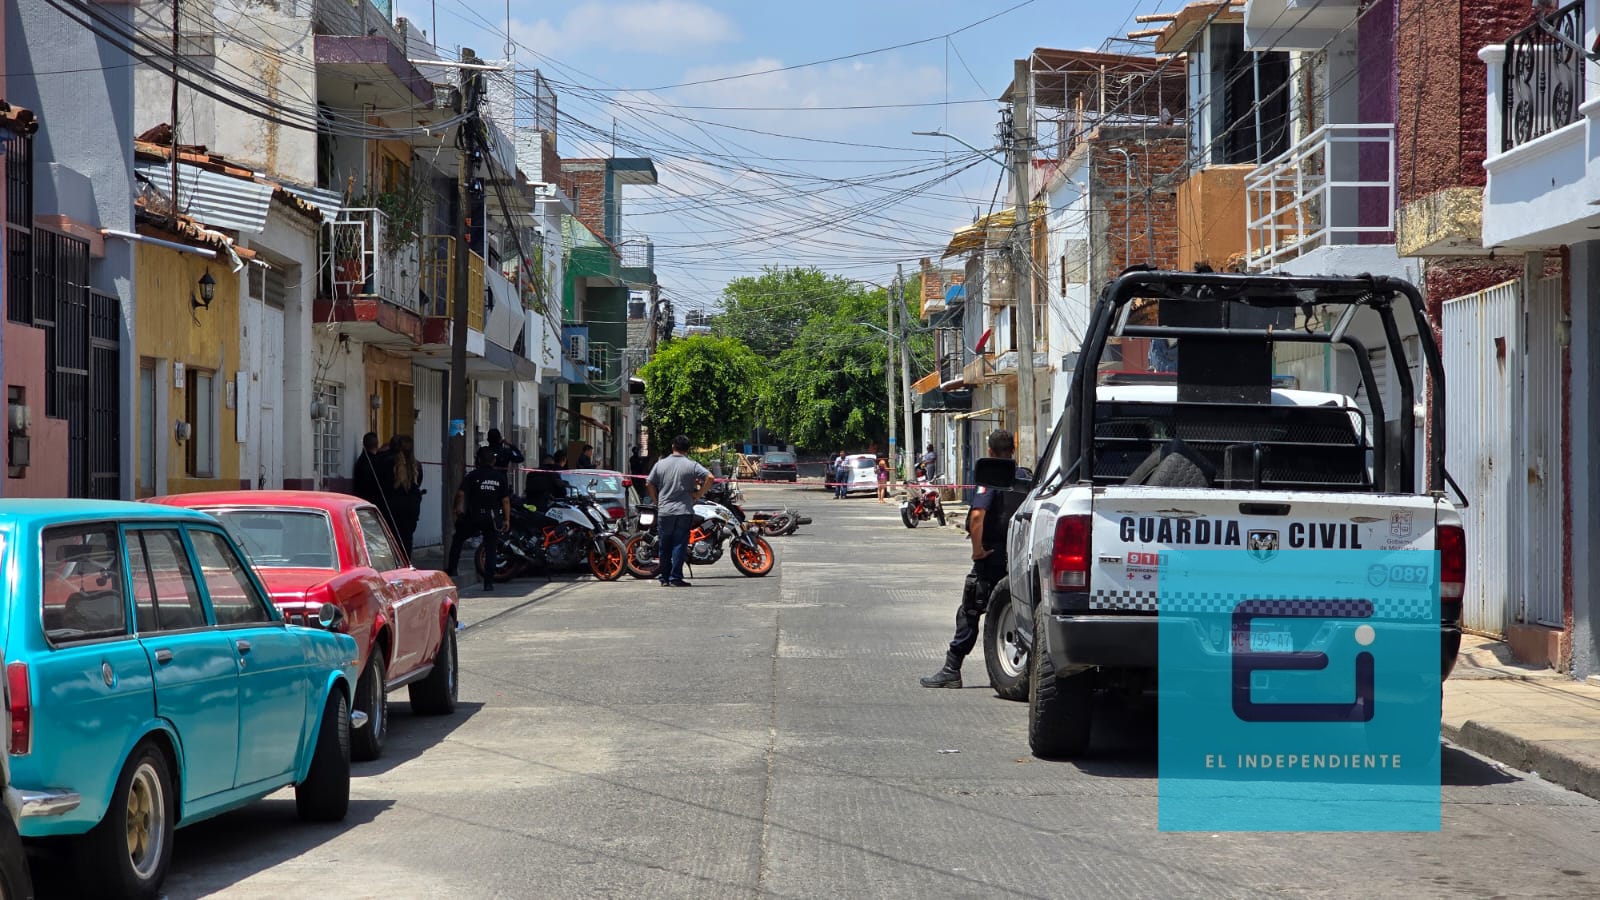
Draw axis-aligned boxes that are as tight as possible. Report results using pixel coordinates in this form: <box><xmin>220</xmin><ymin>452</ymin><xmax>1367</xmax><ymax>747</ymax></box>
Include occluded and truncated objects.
<box><xmin>0</xmin><ymin>500</ymin><xmax>363</xmax><ymax>897</ymax></box>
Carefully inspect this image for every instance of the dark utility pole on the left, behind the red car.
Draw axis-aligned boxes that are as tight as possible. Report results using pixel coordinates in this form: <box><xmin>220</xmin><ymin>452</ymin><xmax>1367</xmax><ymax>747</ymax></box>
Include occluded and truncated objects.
<box><xmin>440</xmin><ymin>48</ymin><xmax>483</xmax><ymax>544</ymax></box>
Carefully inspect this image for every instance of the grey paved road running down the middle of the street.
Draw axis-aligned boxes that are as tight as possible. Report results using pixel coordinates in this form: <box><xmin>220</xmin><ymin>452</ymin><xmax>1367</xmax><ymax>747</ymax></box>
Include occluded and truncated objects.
<box><xmin>28</xmin><ymin>487</ymin><xmax>1600</xmax><ymax>898</ymax></box>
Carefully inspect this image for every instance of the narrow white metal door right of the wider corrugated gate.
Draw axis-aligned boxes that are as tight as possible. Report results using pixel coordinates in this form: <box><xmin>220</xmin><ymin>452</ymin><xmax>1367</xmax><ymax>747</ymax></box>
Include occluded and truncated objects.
<box><xmin>1518</xmin><ymin>277</ymin><xmax>1566</xmax><ymax>628</ymax></box>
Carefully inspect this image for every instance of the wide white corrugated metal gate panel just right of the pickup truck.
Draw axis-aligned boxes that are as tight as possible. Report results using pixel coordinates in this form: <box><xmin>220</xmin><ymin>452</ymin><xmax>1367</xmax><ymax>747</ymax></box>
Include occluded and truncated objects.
<box><xmin>1440</xmin><ymin>282</ymin><xmax>1522</xmax><ymax>636</ymax></box>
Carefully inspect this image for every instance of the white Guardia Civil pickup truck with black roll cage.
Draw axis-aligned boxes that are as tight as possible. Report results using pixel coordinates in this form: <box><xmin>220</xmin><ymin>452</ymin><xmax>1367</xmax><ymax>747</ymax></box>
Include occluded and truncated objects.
<box><xmin>978</xmin><ymin>271</ymin><xmax>1466</xmax><ymax>757</ymax></box>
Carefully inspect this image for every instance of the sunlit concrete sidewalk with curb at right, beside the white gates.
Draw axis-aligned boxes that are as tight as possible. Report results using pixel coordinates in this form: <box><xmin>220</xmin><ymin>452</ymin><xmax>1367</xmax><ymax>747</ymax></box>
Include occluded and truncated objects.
<box><xmin>1442</xmin><ymin>636</ymin><xmax>1600</xmax><ymax>799</ymax></box>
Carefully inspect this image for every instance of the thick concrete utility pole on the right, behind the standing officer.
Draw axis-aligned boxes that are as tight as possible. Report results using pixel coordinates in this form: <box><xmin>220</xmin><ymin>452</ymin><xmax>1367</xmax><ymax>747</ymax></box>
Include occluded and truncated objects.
<box><xmin>1011</xmin><ymin>59</ymin><xmax>1038</xmax><ymax>466</ymax></box>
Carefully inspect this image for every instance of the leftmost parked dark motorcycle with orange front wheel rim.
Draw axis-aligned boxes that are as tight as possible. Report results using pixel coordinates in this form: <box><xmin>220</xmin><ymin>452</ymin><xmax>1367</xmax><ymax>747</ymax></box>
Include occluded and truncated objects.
<box><xmin>474</xmin><ymin>483</ymin><xmax>627</xmax><ymax>581</ymax></box>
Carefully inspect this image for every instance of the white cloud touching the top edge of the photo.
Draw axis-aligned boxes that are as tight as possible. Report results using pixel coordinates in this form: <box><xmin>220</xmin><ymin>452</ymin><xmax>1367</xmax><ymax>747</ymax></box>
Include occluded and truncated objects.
<box><xmin>512</xmin><ymin>0</ymin><xmax>739</xmax><ymax>56</ymax></box>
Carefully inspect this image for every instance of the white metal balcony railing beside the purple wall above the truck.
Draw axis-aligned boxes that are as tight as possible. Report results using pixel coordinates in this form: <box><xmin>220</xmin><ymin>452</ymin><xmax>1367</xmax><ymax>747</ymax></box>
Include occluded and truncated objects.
<box><xmin>1245</xmin><ymin>123</ymin><xmax>1395</xmax><ymax>269</ymax></box>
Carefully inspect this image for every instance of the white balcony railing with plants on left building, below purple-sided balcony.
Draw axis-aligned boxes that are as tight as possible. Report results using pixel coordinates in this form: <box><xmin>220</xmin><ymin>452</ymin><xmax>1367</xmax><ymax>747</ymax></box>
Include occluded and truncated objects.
<box><xmin>322</xmin><ymin>208</ymin><xmax>421</xmax><ymax>312</ymax></box>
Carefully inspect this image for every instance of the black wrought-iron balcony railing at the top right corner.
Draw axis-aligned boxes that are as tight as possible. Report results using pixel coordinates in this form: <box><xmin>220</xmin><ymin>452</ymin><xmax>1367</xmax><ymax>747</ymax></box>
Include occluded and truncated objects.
<box><xmin>1501</xmin><ymin>0</ymin><xmax>1584</xmax><ymax>151</ymax></box>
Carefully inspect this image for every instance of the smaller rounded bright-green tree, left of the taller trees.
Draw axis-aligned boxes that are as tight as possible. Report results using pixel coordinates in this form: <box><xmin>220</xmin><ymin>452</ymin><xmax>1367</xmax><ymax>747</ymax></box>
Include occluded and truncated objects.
<box><xmin>638</xmin><ymin>335</ymin><xmax>766</xmax><ymax>447</ymax></box>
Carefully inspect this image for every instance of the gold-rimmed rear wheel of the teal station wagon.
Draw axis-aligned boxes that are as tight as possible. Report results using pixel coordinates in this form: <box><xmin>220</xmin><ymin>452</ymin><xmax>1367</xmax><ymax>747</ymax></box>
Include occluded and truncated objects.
<box><xmin>78</xmin><ymin>740</ymin><xmax>178</xmax><ymax>898</ymax></box>
